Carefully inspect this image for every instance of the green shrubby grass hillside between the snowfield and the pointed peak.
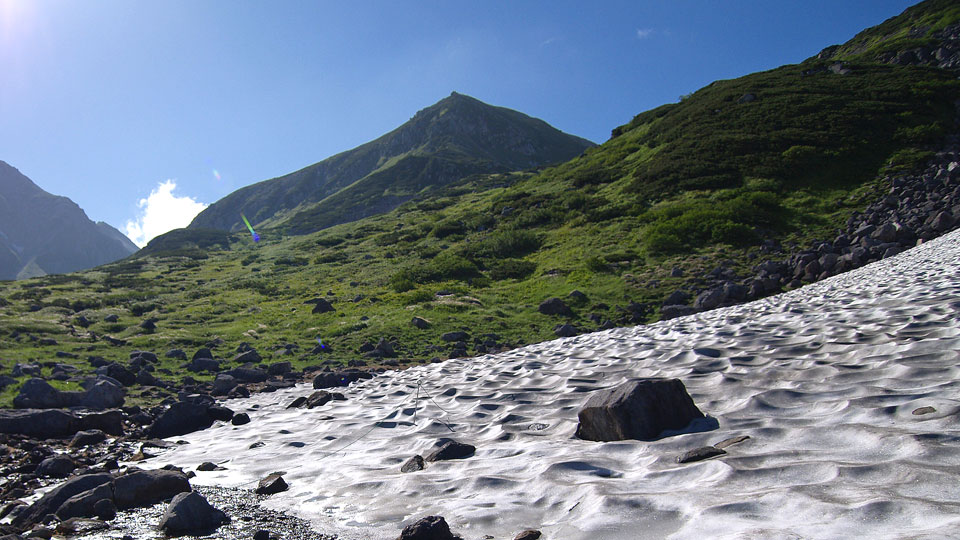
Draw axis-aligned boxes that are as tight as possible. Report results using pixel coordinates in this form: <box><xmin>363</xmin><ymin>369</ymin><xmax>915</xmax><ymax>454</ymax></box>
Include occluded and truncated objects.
<box><xmin>0</xmin><ymin>0</ymin><xmax>960</xmax><ymax>403</ymax></box>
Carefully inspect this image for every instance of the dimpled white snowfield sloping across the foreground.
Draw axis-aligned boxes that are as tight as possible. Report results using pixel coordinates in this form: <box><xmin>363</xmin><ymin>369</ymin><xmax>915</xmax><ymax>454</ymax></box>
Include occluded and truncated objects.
<box><xmin>147</xmin><ymin>232</ymin><xmax>960</xmax><ymax>540</ymax></box>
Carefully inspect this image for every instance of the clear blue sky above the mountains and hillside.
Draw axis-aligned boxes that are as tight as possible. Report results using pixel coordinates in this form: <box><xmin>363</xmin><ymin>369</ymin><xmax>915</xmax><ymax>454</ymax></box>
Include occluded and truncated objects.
<box><xmin>0</xmin><ymin>0</ymin><xmax>914</xmax><ymax>243</ymax></box>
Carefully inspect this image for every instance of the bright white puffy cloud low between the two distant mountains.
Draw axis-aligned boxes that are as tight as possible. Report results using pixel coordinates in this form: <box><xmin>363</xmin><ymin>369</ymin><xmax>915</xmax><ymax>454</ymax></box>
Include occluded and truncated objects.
<box><xmin>124</xmin><ymin>180</ymin><xmax>207</xmax><ymax>247</ymax></box>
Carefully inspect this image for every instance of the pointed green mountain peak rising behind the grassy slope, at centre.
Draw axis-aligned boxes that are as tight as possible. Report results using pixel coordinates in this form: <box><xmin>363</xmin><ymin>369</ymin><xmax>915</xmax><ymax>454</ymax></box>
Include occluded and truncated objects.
<box><xmin>190</xmin><ymin>92</ymin><xmax>595</xmax><ymax>234</ymax></box>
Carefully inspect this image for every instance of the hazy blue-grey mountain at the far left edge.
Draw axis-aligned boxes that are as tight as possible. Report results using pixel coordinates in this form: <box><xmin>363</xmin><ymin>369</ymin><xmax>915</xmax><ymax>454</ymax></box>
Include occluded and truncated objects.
<box><xmin>0</xmin><ymin>161</ymin><xmax>137</xmax><ymax>279</ymax></box>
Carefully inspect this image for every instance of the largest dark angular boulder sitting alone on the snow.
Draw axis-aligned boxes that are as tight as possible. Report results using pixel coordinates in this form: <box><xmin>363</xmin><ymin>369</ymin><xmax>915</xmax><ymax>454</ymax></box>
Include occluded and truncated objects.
<box><xmin>576</xmin><ymin>378</ymin><xmax>704</xmax><ymax>441</ymax></box>
